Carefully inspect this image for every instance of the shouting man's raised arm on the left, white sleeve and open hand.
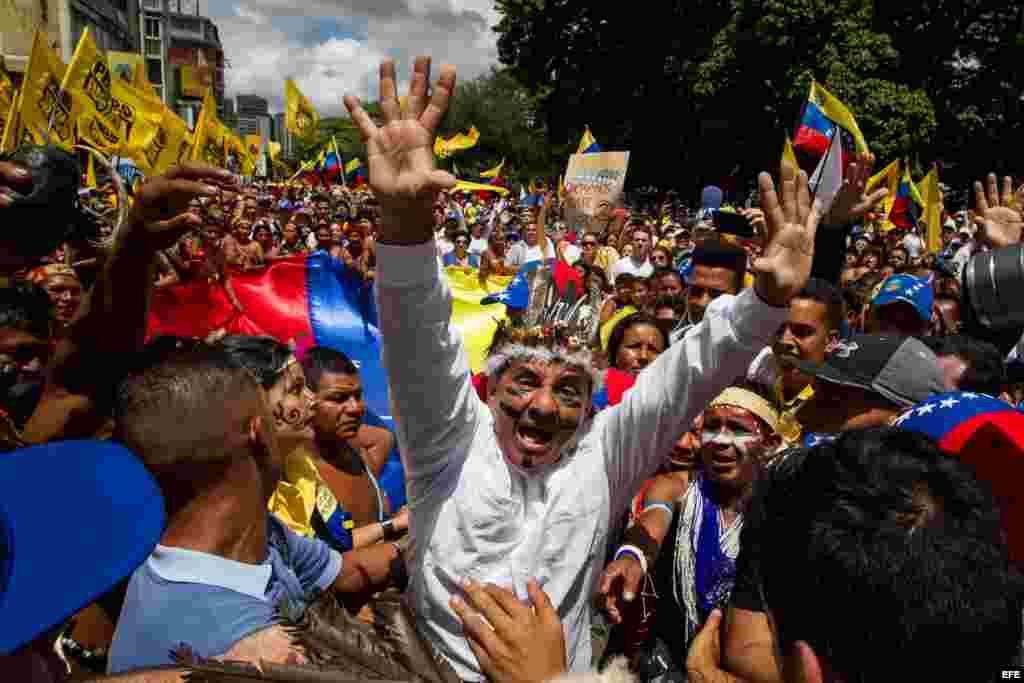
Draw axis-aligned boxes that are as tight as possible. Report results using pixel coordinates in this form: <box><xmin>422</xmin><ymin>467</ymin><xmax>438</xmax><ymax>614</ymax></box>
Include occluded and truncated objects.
<box><xmin>345</xmin><ymin>57</ymin><xmax>484</xmax><ymax>497</ymax></box>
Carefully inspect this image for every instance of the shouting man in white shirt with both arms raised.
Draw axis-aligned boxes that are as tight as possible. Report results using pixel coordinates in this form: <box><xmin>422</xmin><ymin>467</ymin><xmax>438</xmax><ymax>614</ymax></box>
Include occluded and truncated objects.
<box><xmin>345</xmin><ymin>57</ymin><xmax>822</xmax><ymax>680</ymax></box>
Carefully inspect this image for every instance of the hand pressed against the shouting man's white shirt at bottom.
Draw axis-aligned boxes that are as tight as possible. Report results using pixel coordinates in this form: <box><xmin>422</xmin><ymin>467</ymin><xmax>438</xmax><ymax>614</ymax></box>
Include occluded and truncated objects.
<box><xmin>452</xmin><ymin>580</ymin><xmax>565</xmax><ymax>683</ymax></box>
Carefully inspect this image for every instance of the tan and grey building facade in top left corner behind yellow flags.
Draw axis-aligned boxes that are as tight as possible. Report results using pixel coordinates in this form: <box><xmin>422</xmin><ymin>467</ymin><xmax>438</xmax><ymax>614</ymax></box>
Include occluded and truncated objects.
<box><xmin>0</xmin><ymin>0</ymin><xmax>140</xmax><ymax>81</ymax></box>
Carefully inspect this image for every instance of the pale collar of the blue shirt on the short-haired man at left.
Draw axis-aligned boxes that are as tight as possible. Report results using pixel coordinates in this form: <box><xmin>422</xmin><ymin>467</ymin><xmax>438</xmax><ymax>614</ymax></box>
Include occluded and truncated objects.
<box><xmin>146</xmin><ymin>545</ymin><xmax>270</xmax><ymax>600</ymax></box>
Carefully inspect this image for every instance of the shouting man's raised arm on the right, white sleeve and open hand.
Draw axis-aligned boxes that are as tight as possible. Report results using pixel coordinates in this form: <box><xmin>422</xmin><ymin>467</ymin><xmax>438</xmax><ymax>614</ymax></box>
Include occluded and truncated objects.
<box><xmin>598</xmin><ymin>164</ymin><xmax>827</xmax><ymax>518</ymax></box>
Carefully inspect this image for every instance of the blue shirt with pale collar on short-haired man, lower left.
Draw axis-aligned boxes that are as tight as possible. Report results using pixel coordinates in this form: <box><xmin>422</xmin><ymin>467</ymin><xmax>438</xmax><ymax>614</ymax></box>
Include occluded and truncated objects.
<box><xmin>109</xmin><ymin>515</ymin><xmax>342</xmax><ymax>674</ymax></box>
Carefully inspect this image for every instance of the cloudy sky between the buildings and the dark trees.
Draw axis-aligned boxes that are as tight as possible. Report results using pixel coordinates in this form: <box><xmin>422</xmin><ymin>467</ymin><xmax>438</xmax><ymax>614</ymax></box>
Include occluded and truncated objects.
<box><xmin>200</xmin><ymin>0</ymin><xmax>499</xmax><ymax>116</ymax></box>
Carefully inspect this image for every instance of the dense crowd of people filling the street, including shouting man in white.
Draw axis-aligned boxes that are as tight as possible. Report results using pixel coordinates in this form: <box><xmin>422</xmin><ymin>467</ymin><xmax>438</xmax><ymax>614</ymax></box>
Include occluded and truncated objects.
<box><xmin>0</xmin><ymin>57</ymin><xmax>1024</xmax><ymax>683</ymax></box>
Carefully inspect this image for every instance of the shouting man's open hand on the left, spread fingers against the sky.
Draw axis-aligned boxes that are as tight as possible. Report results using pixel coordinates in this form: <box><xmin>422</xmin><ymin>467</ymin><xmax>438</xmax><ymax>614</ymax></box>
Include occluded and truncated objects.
<box><xmin>344</xmin><ymin>57</ymin><xmax>456</xmax><ymax>245</ymax></box>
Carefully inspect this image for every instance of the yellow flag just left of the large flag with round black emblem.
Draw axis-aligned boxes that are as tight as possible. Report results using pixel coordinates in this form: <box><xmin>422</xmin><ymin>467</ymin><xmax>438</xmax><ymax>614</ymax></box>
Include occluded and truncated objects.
<box><xmin>10</xmin><ymin>32</ymin><xmax>82</xmax><ymax>152</ymax></box>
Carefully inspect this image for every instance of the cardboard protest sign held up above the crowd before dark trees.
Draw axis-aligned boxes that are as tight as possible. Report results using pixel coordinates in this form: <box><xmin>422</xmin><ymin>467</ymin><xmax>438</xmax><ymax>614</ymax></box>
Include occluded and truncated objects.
<box><xmin>564</xmin><ymin>152</ymin><xmax>630</xmax><ymax>232</ymax></box>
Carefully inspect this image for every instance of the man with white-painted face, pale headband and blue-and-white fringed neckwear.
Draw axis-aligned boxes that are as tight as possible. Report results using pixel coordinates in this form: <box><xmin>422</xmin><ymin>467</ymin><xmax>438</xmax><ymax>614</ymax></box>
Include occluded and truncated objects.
<box><xmin>599</xmin><ymin>386</ymin><xmax>780</xmax><ymax>680</ymax></box>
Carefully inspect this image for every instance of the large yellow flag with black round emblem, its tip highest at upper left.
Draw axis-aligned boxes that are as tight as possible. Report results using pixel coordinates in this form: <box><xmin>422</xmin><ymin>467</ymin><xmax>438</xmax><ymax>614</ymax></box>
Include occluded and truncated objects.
<box><xmin>62</xmin><ymin>28</ymin><xmax>163</xmax><ymax>164</ymax></box>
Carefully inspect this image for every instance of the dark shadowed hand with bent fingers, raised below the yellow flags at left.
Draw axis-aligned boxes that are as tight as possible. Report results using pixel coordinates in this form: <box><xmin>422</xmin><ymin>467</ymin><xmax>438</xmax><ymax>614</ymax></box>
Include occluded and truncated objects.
<box><xmin>126</xmin><ymin>162</ymin><xmax>238</xmax><ymax>251</ymax></box>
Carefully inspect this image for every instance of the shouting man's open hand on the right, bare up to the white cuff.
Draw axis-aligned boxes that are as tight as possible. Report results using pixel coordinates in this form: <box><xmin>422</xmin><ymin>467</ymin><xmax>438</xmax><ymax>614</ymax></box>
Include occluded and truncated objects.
<box><xmin>754</xmin><ymin>163</ymin><xmax>821</xmax><ymax>307</ymax></box>
